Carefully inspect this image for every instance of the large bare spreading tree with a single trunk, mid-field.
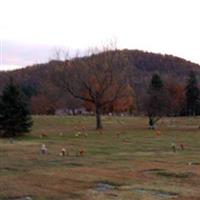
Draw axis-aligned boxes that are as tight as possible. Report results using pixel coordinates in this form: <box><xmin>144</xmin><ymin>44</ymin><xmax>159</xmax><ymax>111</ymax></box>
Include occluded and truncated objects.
<box><xmin>58</xmin><ymin>50</ymin><xmax>128</xmax><ymax>129</ymax></box>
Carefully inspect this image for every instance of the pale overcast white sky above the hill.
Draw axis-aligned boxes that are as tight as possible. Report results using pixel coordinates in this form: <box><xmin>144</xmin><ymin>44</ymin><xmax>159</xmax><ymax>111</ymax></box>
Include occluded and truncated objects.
<box><xmin>0</xmin><ymin>0</ymin><xmax>200</xmax><ymax>70</ymax></box>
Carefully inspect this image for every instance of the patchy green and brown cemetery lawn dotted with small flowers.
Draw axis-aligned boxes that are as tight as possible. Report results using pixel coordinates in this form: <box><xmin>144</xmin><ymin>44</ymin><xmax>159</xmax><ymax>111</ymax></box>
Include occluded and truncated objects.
<box><xmin>0</xmin><ymin>116</ymin><xmax>200</xmax><ymax>200</ymax></box>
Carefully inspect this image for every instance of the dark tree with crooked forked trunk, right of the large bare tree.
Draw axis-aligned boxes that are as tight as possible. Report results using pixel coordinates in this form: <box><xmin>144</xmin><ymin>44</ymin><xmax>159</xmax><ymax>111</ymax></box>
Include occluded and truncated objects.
<box><xmin>146</xmin><ymin>74</ymin><xmax>169</xmax><ymax>128</ymax></box>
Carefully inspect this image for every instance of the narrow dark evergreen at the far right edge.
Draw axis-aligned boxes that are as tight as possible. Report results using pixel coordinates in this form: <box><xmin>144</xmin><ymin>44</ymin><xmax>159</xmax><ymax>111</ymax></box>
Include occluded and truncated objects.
<box><xmin>185</xmin><ymin>72</ymin><xmax>200</xmax><ymax>115</ymax></box>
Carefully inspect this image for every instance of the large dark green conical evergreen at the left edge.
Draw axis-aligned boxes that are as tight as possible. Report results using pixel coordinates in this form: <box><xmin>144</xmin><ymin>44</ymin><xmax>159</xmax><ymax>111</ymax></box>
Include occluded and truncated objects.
<box><xmin>0</xmin><ymin>79</ymin><xmax>32</xmax><ymax>137</ymax></box>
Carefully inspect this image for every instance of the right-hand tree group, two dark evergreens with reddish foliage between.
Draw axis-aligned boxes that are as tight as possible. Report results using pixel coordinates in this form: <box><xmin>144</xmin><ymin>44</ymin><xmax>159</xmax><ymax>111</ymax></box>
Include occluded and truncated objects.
<box><xmin>145</xmin><ymin>71</ymin><xmax>200</xmax><ymax>128</ymax></box>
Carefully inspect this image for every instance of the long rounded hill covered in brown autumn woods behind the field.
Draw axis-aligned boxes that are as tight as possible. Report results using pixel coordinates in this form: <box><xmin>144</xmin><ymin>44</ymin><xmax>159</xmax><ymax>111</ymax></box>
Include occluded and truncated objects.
<box><xmin>0</xmin><ymin>50</ymin><xmax>200</xmax><ymax>114</ymax></box>
